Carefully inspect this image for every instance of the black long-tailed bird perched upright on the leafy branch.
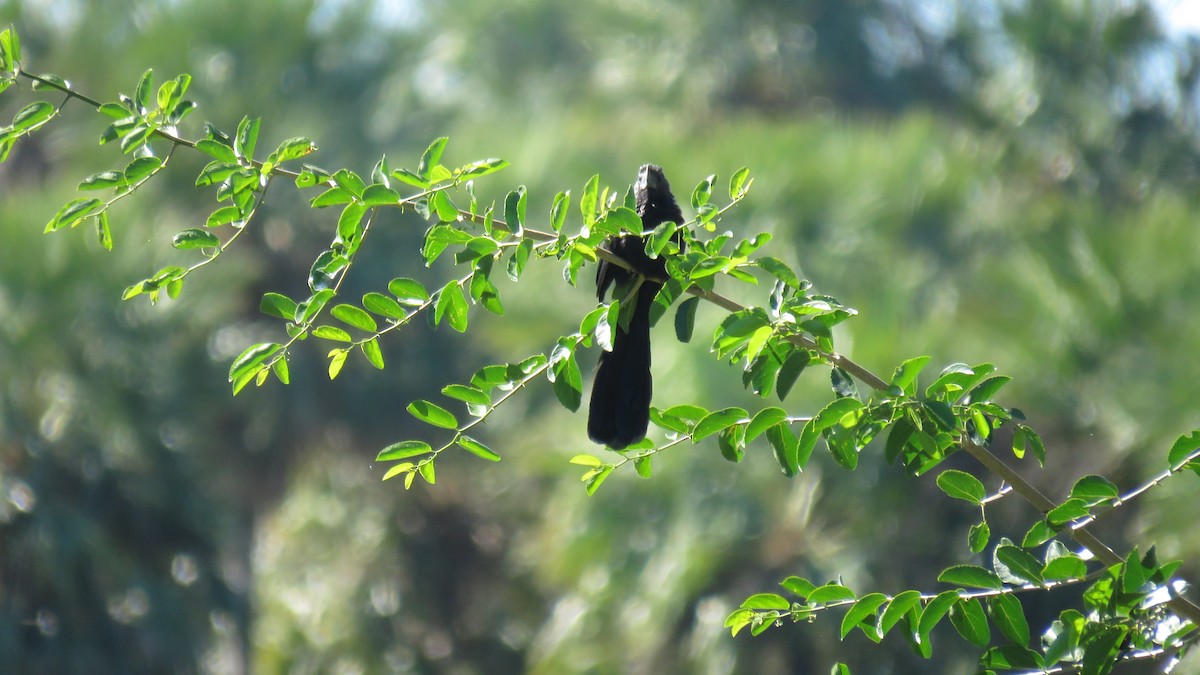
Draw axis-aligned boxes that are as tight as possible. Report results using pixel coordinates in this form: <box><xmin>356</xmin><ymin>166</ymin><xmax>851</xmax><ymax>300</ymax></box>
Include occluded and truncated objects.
<box><xmin>588</xmin><ymin>165</ymin><xmax>683</xmax><ymax>450</ymax></box>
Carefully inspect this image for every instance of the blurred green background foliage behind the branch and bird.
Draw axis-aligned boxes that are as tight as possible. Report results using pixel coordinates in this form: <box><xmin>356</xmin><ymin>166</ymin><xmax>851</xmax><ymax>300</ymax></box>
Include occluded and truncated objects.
<box><xmin>0</xmin><ymin>0</ymin><xmax>1200</xmax><ymax>674</ymax></box>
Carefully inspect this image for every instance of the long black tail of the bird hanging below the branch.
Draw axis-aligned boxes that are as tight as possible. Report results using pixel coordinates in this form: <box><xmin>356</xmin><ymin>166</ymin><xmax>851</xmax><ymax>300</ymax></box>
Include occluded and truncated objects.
<box><xmin>588</xmin><ymin>282</ymin><xmax>661</xmax><ymax>450</ymax></box>
